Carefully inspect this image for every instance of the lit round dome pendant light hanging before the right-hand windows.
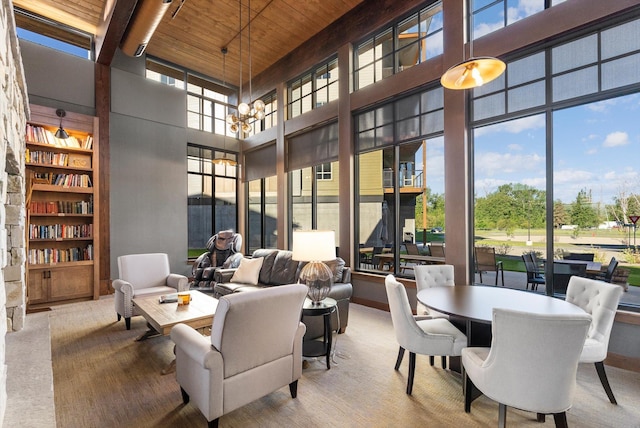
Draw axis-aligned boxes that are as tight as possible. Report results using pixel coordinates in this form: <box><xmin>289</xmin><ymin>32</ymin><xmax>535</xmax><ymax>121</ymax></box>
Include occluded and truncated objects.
<box><xmin>440</xmin><ymin>57</ymin><xmax>507</xmax><ymax>89</ymax></box>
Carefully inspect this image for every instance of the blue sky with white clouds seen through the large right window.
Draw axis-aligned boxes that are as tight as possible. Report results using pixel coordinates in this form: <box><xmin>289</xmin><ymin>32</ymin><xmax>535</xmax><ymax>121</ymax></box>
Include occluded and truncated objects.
<box><xmin>474</xmin><ymin>94</ymin><xmax>640</xmax><ymax>204</ymax></box>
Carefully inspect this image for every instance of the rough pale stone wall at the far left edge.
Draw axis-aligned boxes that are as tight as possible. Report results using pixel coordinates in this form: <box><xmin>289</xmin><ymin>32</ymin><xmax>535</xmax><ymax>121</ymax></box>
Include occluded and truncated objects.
<box><xmin>0</xmin><ymin>0</ymin><xmax>28</xmax><ymax>425</ymax></box>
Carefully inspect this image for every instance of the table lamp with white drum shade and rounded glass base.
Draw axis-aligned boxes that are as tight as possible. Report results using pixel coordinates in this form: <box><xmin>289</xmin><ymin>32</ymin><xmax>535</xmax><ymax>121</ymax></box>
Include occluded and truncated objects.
<box><xmin>292</xmin><ymin>230</ymin><xmax>336</xmax><ymax>305</ymax></box>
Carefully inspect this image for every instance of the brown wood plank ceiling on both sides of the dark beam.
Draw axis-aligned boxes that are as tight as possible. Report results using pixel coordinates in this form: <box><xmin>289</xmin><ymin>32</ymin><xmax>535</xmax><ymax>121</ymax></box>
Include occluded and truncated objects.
<box><xmin>13</xmin><ymin>0</ymin><xmax>363</xmax><ymax>86</ymax></box>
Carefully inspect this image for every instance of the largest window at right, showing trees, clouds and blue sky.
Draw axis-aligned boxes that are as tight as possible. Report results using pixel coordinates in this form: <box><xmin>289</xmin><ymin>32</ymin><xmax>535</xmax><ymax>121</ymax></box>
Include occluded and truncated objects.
<box><xmin>472</xmin><ymin>15</ymin><xmax>640</xmax><ymax>306</ymax></box>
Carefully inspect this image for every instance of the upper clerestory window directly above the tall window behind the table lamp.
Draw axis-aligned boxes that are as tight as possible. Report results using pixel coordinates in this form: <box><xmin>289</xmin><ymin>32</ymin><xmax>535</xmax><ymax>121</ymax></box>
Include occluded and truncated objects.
<box><xmin>288</xmin><ymin>58</ymin><xmax>338</xmax><ymax>119</ymax></box>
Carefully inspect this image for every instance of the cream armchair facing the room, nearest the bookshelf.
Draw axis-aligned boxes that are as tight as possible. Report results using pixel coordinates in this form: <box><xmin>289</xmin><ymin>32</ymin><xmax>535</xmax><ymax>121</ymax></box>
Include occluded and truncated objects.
<box><xmin>111</xmin><ymin>253</ymin><xmax>189</xmax><ymax>330</ymax></box>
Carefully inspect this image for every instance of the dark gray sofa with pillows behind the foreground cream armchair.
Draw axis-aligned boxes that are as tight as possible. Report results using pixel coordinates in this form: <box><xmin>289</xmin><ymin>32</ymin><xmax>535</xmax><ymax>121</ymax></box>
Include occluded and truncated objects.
<box><xmin>214</xmin><ymin>249</ymin><xmax>353</xmax><ymax>338</ymax></box>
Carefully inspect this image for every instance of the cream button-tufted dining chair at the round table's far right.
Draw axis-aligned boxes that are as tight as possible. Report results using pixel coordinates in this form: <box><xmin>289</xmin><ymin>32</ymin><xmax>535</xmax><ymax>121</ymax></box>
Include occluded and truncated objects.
<box><xmin>565</xmin><ymin>276</ymin><xmax>622</xmax><ymax>404</ymax></box>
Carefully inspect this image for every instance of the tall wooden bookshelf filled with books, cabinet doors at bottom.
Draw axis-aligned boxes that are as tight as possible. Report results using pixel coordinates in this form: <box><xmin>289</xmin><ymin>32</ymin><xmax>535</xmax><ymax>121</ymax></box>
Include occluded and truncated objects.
<box><xmin>25</xmin><ymin>104</ymin><xmax>100</xmax><ymax>309</ymax></box>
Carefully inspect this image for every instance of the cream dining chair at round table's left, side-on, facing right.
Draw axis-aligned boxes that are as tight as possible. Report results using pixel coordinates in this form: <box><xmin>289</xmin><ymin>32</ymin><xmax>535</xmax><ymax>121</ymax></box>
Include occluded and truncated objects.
<box><xmin>385</xmin><ymin>275</ymin><xmax>467</xmax><ymax>395</ymax></box>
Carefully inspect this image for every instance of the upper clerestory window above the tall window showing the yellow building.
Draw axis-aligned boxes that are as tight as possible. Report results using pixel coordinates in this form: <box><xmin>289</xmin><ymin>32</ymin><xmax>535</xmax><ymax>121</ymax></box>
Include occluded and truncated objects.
<box><xmin>353</xmin><ymin>1</ymin><xmax>443</xmax><ymax>89</ymax></box>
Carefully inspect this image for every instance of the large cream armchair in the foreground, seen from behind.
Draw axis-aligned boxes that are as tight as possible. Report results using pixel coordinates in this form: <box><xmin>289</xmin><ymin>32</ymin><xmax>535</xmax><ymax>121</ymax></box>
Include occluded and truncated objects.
<box><xmin>171</xmin><ymin>284</ymin><xmax>308</xmax><ymax>427</ymax></box>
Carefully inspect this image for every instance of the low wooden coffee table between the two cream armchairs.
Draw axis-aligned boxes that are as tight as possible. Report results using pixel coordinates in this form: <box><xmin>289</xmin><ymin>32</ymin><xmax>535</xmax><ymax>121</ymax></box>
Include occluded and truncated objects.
<box><xmin>133</xmin><ymin>290</ymin><xmax>218</xmax><ymax>374</ymax></box>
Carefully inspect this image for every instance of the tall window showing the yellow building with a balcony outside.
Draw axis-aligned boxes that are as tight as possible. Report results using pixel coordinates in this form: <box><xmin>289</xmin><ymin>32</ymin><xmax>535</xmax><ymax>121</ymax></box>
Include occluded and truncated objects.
<box><xmin>355</xmin><ymin>88</ymin><xmax>445</xmax><ymax>276</ymax></box>
